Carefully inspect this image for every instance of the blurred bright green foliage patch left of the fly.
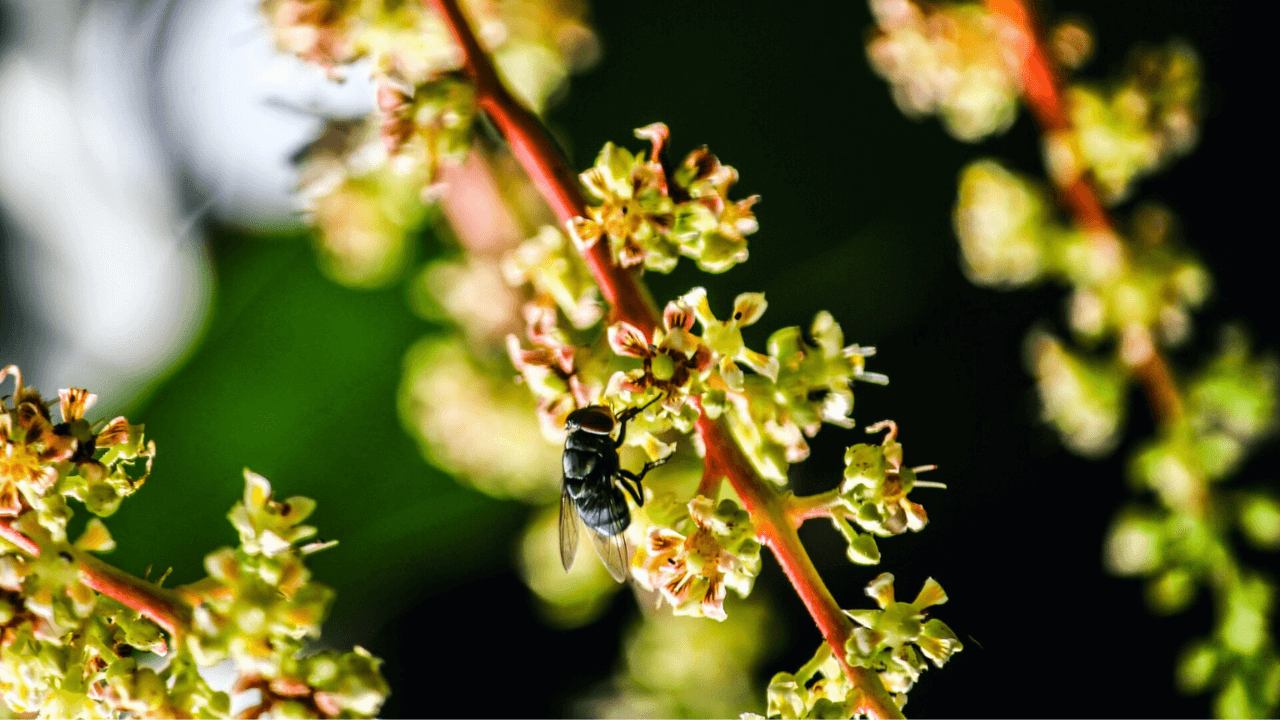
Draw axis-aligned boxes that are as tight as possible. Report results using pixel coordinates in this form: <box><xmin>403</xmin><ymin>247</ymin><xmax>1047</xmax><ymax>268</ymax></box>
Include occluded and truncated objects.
<box><xmin>111</xmin><ymin>232</ymin><xmax>525</xmax><ymax>638</ymax></box>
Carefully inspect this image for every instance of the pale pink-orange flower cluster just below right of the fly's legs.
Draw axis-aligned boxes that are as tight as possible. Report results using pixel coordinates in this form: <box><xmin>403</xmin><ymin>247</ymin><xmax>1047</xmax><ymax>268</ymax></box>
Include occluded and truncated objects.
<box><xmin>631</xmin><ymin>496</ymin><xmax>760</xmax><ymax>620</ymax></box>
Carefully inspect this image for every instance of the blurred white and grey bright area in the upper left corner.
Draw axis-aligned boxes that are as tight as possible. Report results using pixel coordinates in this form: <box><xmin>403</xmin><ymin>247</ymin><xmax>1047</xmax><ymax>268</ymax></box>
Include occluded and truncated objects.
<box><xmin>0</xmin><ymin>0</ymin><xmax>371</xmax><ymax>407</ymax></box>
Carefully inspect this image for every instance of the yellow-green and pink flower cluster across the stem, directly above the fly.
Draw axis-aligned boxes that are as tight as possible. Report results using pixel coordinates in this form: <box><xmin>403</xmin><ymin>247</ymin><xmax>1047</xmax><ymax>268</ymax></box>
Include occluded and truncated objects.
<box><xmin>508</xmin><ymin>263</ymin><xmax>887</xmax><ymax>483</ymax></box>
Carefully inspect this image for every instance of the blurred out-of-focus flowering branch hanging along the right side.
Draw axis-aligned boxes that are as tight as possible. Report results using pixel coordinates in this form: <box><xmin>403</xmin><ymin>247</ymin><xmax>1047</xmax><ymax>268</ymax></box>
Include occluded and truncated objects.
<box><xmin>870</xmin><ymin>0</ymin><xmax>1280</xmax><ymax>717</ymax></box>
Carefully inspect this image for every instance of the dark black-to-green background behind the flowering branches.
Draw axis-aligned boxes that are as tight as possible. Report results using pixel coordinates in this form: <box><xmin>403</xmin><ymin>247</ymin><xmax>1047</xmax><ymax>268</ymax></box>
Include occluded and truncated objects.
<box><xmin>5</xmin><ymin>0</ymin><xmax>1280</xmax><ymax>716</ymax></box>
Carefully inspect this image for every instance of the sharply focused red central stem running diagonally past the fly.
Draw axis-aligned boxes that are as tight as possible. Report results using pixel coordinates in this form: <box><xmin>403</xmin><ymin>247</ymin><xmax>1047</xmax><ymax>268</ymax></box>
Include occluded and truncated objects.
<box><xmin>426</xmin><ymin>0</ymin><xmax>902</xmax><ymax>717</ymax></box>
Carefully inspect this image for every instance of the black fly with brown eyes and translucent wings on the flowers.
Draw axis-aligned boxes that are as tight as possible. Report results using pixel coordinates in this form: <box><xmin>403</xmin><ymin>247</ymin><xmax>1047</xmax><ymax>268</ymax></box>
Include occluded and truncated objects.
<box><xmin>559</xmin><ymin>396</ymin><xmax>671</xmax><ymax>583</ymax></box>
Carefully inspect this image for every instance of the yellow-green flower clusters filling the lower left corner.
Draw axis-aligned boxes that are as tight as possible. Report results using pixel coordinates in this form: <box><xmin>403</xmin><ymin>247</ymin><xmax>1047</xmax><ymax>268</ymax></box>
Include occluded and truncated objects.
<box><xmin>0</xmin><ymin>366</ymin><xmax>387</xmax><ymax>717</ymax></box>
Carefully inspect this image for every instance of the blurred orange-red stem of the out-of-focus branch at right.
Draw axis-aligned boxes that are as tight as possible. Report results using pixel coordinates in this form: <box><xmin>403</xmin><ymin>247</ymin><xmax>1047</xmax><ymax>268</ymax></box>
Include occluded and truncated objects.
<box><xmin>987</xmin><ymin>0</ymin><xmax>1183</xmax><ymax>425</ymax></box>
